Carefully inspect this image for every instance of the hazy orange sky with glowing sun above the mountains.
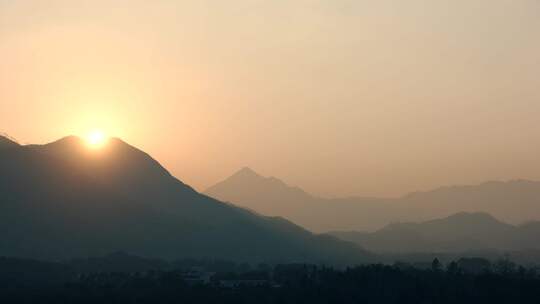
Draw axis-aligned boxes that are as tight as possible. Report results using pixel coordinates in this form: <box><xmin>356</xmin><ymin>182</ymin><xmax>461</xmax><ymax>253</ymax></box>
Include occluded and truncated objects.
<box><xmin>0</xmin><ymin>0</ymin><xmax>540</xmax><ymax>196</ymax></box>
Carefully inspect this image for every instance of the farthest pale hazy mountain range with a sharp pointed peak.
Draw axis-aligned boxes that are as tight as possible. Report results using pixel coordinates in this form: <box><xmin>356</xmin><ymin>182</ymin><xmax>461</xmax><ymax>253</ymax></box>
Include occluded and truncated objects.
<box><xmin>205</xmin><ymin>168</ymin><xmax>540</xmax><ymax>232</ymax></box>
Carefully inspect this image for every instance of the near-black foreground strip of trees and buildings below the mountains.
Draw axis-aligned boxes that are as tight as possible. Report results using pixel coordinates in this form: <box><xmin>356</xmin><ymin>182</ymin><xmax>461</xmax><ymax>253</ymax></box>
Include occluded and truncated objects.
<box><xmin>0</xmin><ymin>255</ymin><xmax>540</xmax><ymax>303</ymax></box>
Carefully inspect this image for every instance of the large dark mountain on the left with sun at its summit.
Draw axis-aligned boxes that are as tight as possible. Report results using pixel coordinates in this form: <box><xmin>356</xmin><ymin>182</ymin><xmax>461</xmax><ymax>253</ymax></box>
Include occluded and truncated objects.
<box><xmin>0</xmin><ymin>136</ymin><xmax>371</xmax><ymax>263</ymax></box>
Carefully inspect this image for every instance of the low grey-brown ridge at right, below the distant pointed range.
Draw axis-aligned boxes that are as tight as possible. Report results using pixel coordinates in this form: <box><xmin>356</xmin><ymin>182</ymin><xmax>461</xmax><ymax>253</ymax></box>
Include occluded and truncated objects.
<box><xmin>330</xmin><ymin>212</ymin><xmax>540</xmax><ymax>253</ymax></box>
